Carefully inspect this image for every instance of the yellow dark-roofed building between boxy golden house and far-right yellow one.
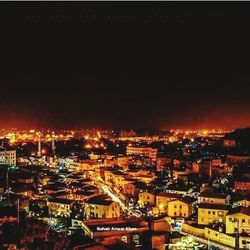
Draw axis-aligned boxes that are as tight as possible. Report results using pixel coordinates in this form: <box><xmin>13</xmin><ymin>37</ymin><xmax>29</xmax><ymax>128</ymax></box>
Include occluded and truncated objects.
<box><xmin>198</xmin><ymin>203</ymin><xmax>229</xmax><ymax>225</ymax></box>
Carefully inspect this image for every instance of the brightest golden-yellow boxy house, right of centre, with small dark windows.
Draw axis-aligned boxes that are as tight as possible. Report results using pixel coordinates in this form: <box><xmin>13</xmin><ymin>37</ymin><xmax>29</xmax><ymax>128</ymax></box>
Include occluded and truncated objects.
<box><xmin>168</xmin><ymin>197</ymin><xmax>195</xmax><ymax>218</ymax></box>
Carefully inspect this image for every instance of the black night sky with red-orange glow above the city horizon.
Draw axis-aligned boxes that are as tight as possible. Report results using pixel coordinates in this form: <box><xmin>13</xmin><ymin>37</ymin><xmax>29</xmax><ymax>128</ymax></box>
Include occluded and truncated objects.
<box><xmin>0</xmin><ymin>2</ymin><xmax>250</xmax><ymax>128</ymax></box>
